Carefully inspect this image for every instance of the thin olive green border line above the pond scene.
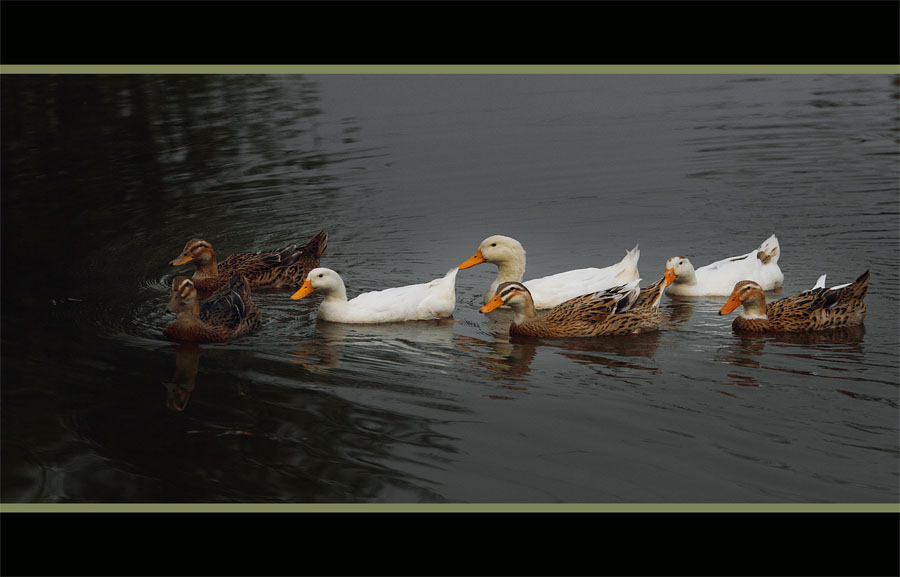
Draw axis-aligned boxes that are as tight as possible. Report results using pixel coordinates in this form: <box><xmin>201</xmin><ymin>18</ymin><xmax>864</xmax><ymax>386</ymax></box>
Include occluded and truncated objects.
<box><xmin>0</xmin><ymin>64</ymin><xmax>900</xmax><ymax>74</ymax></box>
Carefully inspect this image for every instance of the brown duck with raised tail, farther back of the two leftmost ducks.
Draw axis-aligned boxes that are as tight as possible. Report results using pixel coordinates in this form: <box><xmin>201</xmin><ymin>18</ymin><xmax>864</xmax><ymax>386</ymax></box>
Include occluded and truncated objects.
<box><xmin>169</xmin><ymin>230</ymin><xmax>328</xmax><ymax>292</ymax></box>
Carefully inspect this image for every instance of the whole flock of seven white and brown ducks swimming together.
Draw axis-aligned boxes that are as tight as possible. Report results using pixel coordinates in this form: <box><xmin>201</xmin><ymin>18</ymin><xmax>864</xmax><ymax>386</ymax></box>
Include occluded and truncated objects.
<box><xmin>163</xmin><ymin>231</ymin><xmax>869</xmax><ymax>342</ymax></box>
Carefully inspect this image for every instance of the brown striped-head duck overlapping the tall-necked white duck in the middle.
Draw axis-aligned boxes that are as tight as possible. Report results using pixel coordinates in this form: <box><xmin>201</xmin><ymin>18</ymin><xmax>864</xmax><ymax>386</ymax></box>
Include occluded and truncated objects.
<box><xmin>479</xmin><ymin>277</ymin><xmax>669</xmax><ymax>337</ymax></box>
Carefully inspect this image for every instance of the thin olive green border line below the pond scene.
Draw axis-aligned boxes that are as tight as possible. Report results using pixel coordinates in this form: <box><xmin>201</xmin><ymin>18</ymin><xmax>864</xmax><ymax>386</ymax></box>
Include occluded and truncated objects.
<box><xmin>0</xmin><ymin>503</ymin><xmax>900</xmax><ymax>513</ymax></box>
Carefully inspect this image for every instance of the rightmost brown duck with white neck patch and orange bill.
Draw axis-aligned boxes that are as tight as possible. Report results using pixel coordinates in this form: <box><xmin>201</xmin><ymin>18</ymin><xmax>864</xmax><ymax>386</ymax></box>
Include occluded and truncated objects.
<box><xmin>719</xmin><ymin>270</ymin><xmax>869</xmax><ymax>332</ymax></box>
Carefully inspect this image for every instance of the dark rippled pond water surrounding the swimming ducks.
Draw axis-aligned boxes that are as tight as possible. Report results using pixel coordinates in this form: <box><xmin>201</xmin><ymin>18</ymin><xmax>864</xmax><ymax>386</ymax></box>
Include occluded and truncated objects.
<box><xmin>2</xmin><ymin>75</ymin><xmax>900</xmax><ymax>503</ymax></box>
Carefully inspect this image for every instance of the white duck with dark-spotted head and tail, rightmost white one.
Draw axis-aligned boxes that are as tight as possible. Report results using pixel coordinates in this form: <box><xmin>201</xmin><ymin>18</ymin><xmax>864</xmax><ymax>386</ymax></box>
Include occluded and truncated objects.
<box><xmin>666</xmin><ymin>234</ymin><xmax>784</xmax><ymax>296</ymax></box>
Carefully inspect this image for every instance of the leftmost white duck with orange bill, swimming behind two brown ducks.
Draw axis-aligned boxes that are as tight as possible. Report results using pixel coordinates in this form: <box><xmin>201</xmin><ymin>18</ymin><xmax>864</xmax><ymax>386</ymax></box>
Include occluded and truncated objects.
<box><xmin>291</xmin><ymin>268</ymin><xmax>459</xmax><ymax>323</ymax></box>
